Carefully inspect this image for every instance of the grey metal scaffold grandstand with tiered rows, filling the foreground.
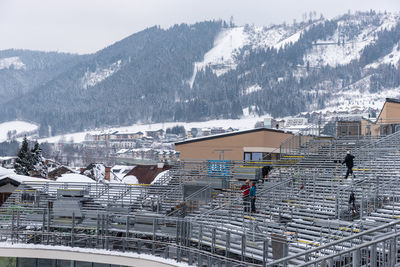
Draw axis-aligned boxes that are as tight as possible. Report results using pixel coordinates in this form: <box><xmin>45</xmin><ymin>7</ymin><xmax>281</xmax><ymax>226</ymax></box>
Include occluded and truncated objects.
<box><xmin>0</xmin><ymin>119</ymin><xmax>400</xmax><ymax>267</ymax></box>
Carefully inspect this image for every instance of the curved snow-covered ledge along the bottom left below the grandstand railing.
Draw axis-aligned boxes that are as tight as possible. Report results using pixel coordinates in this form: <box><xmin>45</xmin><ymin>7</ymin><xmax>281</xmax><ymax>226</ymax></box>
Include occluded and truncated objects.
<box><xmin>0</xmin><ymin>242</ymin><xmax>189</xmax><ymax>267</ymax></box>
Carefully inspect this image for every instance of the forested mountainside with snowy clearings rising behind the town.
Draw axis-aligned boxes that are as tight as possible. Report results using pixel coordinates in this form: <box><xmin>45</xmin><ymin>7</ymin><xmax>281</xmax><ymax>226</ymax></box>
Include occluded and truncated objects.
<box><xmin>0</xmin><ymin>11</ymin><xmax>400</xmax><ymax>135</ymax></box>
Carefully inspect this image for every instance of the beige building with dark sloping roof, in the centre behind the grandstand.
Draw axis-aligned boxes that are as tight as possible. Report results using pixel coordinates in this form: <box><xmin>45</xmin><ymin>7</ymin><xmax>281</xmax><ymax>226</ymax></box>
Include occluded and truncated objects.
<box><xmin>175</xmin><ymin>128</ymin><xmax>293</xmax><ymax>161</ymax></box>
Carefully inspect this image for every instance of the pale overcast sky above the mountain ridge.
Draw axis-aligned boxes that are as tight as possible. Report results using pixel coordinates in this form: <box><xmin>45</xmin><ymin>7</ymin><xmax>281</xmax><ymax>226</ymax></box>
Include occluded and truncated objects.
<box><xmin>0</xmin><ymin>0</ymin><xmax>400</xmax><ymax>54</ymax></box>
